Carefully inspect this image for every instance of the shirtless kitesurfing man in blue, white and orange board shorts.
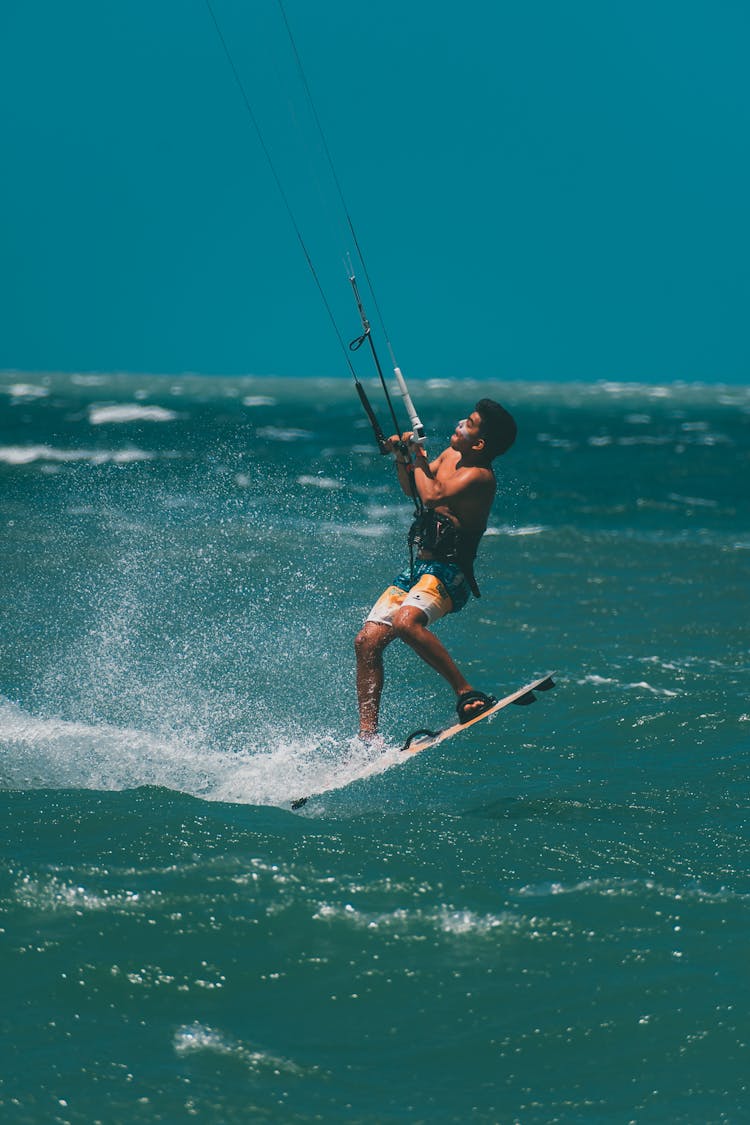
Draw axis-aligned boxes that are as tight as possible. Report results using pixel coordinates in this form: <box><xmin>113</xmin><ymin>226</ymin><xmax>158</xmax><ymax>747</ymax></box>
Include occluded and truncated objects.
<box><xmin>354</xmin><ymin>398</ymin><xmax>516</xmax><ymax>739</ymax></box>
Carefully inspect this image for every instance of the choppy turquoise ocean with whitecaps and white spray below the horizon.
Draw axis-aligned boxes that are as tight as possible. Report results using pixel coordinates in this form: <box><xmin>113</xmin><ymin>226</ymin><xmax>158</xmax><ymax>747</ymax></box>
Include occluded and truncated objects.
<box><xmin>0</xmin><ymin>372</ymin><xmax>750</xmax><ymax>1125</ymax></box>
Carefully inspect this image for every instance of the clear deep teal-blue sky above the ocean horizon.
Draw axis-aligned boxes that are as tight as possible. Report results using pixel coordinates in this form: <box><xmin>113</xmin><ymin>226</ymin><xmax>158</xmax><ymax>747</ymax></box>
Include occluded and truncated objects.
<box><xmin>0</xmin><ymin>0</ymin><xmax>750</xmax><ymax>384</ymax></box>
